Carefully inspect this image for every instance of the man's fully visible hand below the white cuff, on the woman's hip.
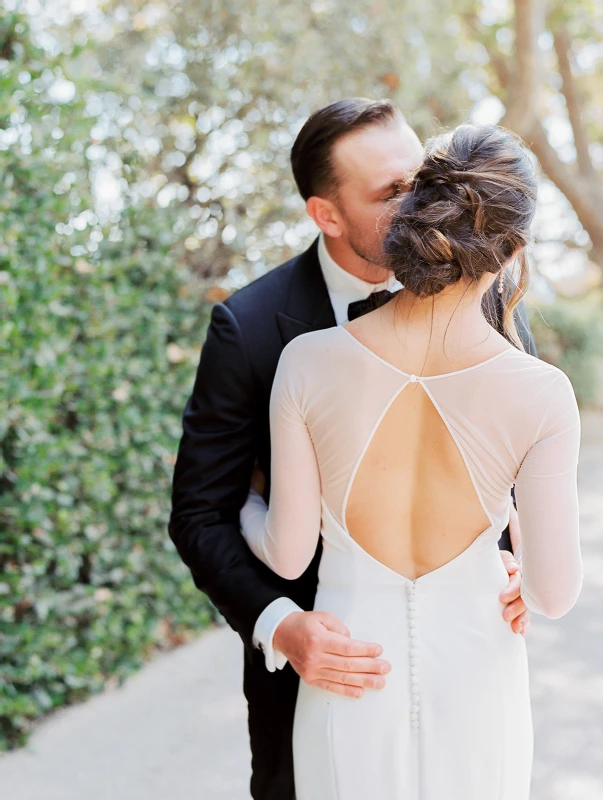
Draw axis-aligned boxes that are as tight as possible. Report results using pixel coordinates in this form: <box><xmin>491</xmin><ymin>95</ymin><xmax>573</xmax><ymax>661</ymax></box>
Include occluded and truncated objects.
<box><xmin>273</xmin><ymin>611</ymin><xmax>391</xmax><ymax>697</ymax></box>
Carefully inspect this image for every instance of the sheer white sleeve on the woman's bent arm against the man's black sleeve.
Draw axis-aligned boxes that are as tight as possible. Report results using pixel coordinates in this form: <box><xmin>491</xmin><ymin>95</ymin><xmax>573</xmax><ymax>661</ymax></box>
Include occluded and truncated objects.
<box><xmin>241</xmin><ymin>341</ymin><xmax>321</xmax><ymax>580</ymax></box>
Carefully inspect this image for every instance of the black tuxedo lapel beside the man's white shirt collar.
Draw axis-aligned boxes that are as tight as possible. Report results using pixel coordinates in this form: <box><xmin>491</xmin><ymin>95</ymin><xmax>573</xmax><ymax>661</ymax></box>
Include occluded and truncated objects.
<box><xmin>276</xmin><ymin>234</ymin><xmax>336</xmax><ymax>345</ymax></box>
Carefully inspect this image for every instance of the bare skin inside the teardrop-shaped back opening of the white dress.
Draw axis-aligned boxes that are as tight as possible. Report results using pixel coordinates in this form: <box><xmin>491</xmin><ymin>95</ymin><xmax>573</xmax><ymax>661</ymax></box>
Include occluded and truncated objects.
<box><xmin>345</xmin><ymin>366</ymin><xmax>490</xmax><ymax>578</ymax></box>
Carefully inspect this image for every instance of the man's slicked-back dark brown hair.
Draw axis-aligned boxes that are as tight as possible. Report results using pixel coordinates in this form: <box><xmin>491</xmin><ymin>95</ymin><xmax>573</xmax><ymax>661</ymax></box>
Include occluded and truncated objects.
<box><xmin>291</xmin><ymin>97</ymin><xmax>404</xmax><ymax>200</ymax></box>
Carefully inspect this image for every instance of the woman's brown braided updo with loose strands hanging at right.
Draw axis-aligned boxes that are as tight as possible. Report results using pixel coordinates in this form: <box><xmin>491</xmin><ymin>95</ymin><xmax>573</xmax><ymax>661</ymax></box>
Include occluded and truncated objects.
<box><xmin>384</xmin><ymin>124</ymin><xmax>537</xmax><ymax>347</ymax></box>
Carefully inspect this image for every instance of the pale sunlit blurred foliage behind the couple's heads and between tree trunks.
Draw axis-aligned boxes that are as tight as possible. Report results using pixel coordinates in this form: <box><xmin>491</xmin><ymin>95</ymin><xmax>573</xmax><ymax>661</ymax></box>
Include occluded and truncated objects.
<box><xmin>56</xmin><ymin>0</ymin><xmax>603</xmax><ymax>287</ymax></box>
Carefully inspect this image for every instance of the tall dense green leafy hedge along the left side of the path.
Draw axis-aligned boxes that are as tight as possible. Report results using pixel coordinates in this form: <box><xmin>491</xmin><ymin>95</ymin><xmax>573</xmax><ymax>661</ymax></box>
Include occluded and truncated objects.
<box><xmin>0</xmin><ymin>10</ymin><xmax>217</xmax><ymax>748</ymax></box>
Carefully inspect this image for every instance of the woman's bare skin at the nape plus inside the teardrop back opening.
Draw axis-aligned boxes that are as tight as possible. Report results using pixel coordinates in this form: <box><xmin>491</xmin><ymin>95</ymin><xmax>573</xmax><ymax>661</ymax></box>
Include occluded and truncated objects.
<box><xmin>345</xmin><ymin>298</ymin><xmax>510</xmax><ymax>578</ymax></box>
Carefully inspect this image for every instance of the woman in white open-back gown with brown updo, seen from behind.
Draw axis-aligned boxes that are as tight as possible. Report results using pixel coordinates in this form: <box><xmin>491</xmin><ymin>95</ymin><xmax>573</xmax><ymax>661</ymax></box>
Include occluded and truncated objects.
<box><xmin>241</xmin><ymin>125</ymin><xmax>582</xmax><ymax>800</ymax></box>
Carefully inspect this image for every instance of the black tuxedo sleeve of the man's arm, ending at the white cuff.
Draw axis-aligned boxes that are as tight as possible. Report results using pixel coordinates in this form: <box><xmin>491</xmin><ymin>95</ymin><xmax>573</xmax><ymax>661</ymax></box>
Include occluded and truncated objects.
<box><xmin>169</xmin><ymin>305</ymin><xmax>283</xmax><ymax>648</ymax></box>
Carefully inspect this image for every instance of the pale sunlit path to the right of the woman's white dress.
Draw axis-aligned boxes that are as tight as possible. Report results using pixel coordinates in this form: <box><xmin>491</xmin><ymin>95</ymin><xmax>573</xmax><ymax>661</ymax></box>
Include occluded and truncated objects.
<box><xmin>528</xmin><ymin>414</ymin><xmax>603</xmax><ymax>800</ymax></box>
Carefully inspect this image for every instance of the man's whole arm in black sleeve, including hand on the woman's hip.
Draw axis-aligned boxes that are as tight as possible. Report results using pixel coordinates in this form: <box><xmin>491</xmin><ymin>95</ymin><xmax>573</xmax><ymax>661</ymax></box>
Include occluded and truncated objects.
<box><xmin>169</xmin><ymin>305</ymin><xmax>389</xmax><ymax>697</ymax></box>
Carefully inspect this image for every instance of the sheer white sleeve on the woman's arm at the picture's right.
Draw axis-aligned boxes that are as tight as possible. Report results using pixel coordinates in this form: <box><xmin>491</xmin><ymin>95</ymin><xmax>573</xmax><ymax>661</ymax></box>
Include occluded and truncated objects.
<box><xmin>515</xmin><ymin>373</ymin><xmax>582</xmax><ymax>619</ymax></box>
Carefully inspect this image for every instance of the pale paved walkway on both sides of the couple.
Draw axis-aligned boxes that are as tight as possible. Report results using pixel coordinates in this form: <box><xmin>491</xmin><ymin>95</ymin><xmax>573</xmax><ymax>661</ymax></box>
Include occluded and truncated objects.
<box><xmin>0</xmin><ymin>415</ymin><xmax>603</xmax><ymax>800</ymax></box>
